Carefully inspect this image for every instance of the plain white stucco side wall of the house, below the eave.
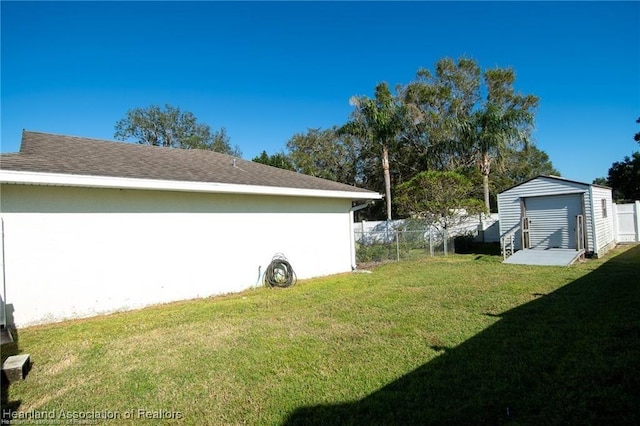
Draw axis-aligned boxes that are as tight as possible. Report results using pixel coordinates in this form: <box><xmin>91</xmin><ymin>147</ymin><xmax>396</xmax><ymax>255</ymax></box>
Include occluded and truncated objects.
<box><xmin>1</xmin><ymin>185</ymin><xmax>351</xmax><ymax>326</ymax></box>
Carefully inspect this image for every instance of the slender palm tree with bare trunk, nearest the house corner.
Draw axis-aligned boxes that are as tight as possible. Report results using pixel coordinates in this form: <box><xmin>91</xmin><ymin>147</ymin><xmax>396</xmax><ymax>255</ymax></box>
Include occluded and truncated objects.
<box><xmin>340</xmin><ymin>82</ymin><xmax>405</xmax><ymax>220</ymax></box>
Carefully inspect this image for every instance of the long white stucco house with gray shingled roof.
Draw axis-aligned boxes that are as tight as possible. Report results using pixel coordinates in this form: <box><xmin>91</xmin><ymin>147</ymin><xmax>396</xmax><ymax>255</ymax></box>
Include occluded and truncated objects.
<box><xmin>0</xmin><ymin>131</ymin><xmax>381</xmax><ymax>327</ymax></box>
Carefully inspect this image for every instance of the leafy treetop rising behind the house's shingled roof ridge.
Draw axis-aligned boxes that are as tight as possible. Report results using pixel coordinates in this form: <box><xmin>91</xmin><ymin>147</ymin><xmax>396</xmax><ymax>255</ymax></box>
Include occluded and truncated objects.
<box><xmin>114</xmin><ymin>105</ymin><xmax>242</xmax><ymax>157</ymax></box>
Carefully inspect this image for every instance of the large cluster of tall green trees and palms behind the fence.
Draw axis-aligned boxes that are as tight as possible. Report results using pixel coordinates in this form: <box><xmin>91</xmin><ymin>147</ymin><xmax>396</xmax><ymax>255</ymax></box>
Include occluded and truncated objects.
<box><xmin>242</xmin><ymin>57</ymin><xmax>552</xmax><ymax>219</ymax></box>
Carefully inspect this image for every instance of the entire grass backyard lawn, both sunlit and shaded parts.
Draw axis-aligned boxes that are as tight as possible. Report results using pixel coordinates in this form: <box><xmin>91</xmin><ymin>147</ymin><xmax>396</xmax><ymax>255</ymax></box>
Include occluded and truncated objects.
<box><xmin>2</xmin><ymin>246</ymin><xmax>640</xmax><ymax>425</ymax></box>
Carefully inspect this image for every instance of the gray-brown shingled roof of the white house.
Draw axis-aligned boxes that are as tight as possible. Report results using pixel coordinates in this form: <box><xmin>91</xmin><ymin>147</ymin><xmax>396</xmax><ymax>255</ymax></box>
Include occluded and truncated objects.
<box><xmin>0</xmin><ymin>131</ymin><xmax>377</xmax><ymax>196</ymax></box>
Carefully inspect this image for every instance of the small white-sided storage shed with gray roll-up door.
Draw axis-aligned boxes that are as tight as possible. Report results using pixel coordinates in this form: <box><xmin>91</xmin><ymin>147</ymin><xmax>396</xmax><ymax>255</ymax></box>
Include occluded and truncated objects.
<box><xmin>498</xmin><ymin>176</ymin><xmax>615</xmax><ymax>257</ymax></box>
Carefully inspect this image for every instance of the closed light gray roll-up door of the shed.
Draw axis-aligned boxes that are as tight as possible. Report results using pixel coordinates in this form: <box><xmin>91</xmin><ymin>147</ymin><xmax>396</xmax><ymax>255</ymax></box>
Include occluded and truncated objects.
<box><xmin>525</xmin><ymin>194</ymin><xmax>583</xmax><ymax>249</ymax></box>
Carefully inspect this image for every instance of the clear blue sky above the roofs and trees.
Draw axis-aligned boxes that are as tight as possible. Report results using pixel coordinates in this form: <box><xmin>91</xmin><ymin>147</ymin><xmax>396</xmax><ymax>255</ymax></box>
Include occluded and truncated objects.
<box><xmin>0</xmin><ymin>1</ymin><xmax>640</xmax><ymax>182</ymax></box>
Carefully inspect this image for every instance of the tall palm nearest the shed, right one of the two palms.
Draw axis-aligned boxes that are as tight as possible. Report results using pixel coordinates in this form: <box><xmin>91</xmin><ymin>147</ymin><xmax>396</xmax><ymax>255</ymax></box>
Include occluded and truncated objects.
<box><xmin>467</xmin><ymin>68</ymin><xmax>538</xmax><ymax>209</ymax></box>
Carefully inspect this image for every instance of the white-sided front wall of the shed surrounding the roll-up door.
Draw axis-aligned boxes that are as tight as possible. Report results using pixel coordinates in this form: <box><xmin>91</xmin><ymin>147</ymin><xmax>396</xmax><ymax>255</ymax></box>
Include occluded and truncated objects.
<box><xmin>498</xmin><ymin>177</ymin><xmax>594</xmax><ymax>250</ymax></box>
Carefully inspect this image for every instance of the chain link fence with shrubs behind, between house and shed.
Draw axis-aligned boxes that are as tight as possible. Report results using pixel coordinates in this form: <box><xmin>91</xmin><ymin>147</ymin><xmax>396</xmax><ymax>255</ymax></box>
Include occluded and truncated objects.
<box><xmin>354</xmin><ymin>221</ymin><xmax>459</xmax><ymax>263</ymax></box>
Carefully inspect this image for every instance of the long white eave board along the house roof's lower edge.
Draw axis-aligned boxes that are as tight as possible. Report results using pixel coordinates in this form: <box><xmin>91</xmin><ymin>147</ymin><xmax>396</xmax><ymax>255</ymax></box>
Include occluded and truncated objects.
<box><xmin>0</xmin><ymin>170</ymin><xmax>382</xmax><ymax>200</ymax></box>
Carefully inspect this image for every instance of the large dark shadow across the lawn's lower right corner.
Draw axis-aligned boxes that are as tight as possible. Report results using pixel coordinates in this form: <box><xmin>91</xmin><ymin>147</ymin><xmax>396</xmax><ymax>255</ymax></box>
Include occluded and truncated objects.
<box><xmin>285</xmin><ymin>246</ymin><xmax>640</xmax><ymax>425</ymax></box>
